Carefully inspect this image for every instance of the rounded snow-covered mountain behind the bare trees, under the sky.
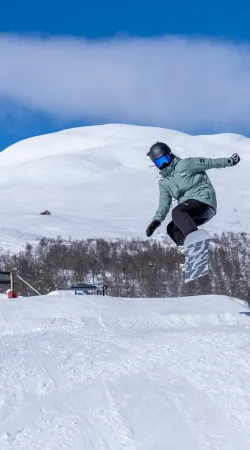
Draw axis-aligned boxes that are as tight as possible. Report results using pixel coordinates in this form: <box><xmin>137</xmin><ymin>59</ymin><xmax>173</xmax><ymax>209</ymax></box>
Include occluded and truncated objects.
<box><xmin>0</xmin><ymin>125</ymin><xmax>250</xmax><ymax>250</ymax></box>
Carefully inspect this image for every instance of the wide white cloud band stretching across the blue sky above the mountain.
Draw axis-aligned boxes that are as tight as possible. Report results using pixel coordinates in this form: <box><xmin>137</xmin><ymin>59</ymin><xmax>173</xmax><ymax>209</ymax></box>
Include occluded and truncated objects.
<box><xmin>0</xmin><ymin>34</ymin><xmax>250</xmax><ymax>129</ymax></box>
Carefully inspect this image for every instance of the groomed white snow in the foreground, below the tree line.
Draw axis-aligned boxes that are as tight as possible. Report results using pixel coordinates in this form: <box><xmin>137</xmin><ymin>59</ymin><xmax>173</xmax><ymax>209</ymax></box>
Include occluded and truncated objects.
<box><xmin>0</xmin><ymin>291</ymin><xmax>250</xmax><ymax>450</ymax></box>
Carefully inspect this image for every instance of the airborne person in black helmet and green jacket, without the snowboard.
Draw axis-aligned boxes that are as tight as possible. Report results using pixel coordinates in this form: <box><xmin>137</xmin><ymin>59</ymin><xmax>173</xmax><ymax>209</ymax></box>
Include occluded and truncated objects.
<box><xmin>146</xmin><ymin>142</ymin><xmax>240</xmax><ymax>246</ymax></box>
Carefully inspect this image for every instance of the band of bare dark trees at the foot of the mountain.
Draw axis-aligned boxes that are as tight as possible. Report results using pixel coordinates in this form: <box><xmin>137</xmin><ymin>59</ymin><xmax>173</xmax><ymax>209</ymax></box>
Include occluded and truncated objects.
<box><xmin>0</xmin><ymin>233</ymin><xmax>250</xmax><ymax>304</ymax></box>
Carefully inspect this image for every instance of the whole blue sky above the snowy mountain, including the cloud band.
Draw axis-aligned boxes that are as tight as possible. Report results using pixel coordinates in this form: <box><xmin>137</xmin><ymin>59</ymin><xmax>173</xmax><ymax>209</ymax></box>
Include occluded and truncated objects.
<box><xmin>0</xmin><ymin>0</ymin><xmax>250</xmax><ymax>149</ymax></box>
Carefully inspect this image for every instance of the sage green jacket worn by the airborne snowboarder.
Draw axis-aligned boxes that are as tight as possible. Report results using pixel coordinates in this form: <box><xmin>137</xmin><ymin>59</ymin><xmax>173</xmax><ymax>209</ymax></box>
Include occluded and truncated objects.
<box><xmin>154</xmin><ymin>157</ymin><xmax>232</xmax><ymax>222</ymax></box>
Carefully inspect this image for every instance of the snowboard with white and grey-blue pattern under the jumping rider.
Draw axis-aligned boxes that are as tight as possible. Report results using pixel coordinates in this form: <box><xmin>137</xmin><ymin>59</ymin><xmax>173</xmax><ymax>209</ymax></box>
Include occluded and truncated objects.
<box><xmin>183</xmin><ymin>230</ymin><xmax>211</xmax><ymax>283</ymax></box>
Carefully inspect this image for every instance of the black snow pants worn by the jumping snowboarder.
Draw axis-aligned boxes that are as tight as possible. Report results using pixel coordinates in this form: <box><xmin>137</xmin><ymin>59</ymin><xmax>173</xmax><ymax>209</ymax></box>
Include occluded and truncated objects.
<box><xmin>167</xmin><ymin>200</ymin><xmax>216</xmax><ymax>245</ymax></box>
